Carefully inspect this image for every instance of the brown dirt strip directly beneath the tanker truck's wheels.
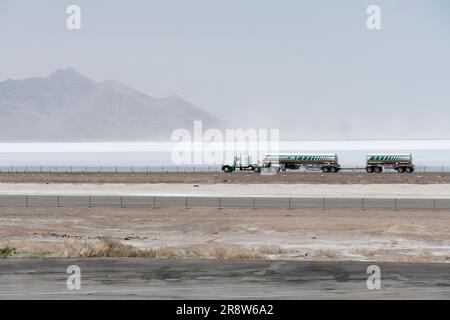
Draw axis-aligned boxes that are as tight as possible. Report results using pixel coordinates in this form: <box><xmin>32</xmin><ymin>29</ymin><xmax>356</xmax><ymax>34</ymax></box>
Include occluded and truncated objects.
<box><xmin>0</xmin><ymin>171</ymin><xmax>450</xmax><ymax>184</ymax></box>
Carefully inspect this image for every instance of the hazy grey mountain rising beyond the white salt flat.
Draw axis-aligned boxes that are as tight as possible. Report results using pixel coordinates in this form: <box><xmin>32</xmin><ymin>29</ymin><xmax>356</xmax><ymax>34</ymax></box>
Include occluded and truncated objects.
<box><xmin>0</xmin><ymin>68</ymin><xmax>225</xmax><ymax>141</ymax></box>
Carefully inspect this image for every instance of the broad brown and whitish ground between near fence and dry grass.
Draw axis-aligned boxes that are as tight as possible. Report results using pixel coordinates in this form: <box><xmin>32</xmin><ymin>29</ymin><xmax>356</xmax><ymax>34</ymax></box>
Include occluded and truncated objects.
<box><xmin>0</xmin><ymin>207</ymin><xmax>450</xmax><ymax>262</ymax></box>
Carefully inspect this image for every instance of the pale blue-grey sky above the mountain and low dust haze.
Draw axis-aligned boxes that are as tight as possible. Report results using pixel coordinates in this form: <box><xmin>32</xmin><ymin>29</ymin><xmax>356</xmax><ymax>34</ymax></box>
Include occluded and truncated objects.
<box><xmin>0</xmin><ymin>0</ymin><xmax>450</xmax><ymax>134</ymax></box>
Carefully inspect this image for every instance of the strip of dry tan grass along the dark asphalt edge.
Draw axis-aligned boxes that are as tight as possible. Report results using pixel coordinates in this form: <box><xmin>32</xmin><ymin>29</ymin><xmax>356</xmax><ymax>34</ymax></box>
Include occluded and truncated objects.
<box><xmin>0</xmin><ymin>237</ymin><xmax>450</xmax><ymax>263</ymax></box>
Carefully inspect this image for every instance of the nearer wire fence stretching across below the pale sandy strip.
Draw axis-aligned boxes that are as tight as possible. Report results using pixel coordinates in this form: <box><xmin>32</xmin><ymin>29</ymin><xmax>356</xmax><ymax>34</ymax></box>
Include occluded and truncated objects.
<box><xmin>0</xmin><ymin>195</ymin><xmax>450</xmax><ymax>210</ymax></box>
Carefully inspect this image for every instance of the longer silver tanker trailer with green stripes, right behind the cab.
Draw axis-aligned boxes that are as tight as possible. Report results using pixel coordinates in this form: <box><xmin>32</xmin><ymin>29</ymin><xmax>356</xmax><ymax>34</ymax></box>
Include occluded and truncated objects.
<box><xmin>262</xmin><ymin>153</ymin><xmax>341</xmax><ymax>173</ymax></box>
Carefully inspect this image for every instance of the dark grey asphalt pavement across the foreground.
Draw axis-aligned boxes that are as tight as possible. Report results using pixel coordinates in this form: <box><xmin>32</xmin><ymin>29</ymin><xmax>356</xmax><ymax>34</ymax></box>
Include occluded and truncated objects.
<box><xmin>0</xmin><ymin>258</ymin><xmax>450</xmax><ymax>299</ymax></box>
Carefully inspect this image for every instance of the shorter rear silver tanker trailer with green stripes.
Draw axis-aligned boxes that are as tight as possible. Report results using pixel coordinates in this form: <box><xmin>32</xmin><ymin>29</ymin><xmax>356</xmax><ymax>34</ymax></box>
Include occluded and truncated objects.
<box><xmin>366</xmin><ymin>153</ymin><xmax>414</xmax><ymax>173</ymax></box>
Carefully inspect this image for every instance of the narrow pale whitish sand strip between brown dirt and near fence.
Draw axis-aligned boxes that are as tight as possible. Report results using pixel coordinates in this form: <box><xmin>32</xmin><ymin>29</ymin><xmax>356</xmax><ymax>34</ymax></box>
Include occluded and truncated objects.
<box><xmin>0</xmin><ymin>183</ymin><xmax>450</xmax><ymax>199</ymax></box>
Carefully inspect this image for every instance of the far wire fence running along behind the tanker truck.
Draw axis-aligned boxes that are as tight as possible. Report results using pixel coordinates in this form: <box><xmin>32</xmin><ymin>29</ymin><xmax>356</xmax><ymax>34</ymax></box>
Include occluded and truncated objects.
<box><xmin>0</xmin><ymin>165</ymin><xmax>450</xmax><ymax>174</ymax></box>
